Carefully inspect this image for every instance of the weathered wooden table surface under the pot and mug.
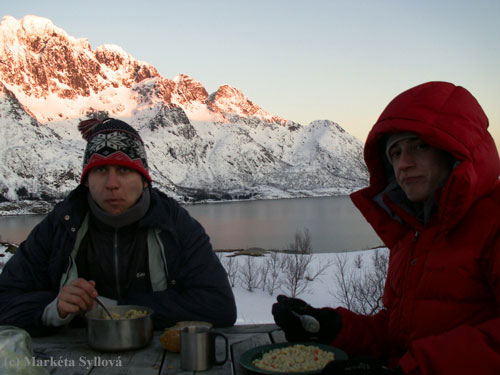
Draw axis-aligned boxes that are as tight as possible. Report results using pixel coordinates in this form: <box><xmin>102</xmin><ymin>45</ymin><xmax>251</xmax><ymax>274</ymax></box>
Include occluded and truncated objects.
<box><xmin>32</xmin><ymin>324</ymin><xmax>286</xmax><ymax>375</ymax></box>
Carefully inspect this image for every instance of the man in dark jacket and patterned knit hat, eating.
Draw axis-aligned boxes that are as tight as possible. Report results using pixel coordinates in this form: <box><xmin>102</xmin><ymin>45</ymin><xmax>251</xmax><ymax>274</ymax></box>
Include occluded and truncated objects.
<box><xmin>0</xmin><ymin>119</ymin><xmax>236</xmax><ymax>334</ymax></box>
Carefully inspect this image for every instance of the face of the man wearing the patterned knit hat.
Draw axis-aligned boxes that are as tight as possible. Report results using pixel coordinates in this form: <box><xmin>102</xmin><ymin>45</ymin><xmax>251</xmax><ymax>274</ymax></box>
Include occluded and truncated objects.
<box><xmin>85</xmin><ymin>165</ymin><xmax>147</xmax><ymax>215</ymax></box>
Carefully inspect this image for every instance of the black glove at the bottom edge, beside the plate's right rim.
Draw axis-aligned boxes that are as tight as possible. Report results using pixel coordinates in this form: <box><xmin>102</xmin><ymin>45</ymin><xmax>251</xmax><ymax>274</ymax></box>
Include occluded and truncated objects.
<box><xmin>321</xmin><ymin>357</ymin><xmax>403</xmax><ymax>375</ymax></box>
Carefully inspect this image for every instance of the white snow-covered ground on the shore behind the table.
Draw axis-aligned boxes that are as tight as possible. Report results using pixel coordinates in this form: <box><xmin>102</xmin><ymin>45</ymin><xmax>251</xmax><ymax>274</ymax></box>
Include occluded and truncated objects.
<box><xmin>0</xmin><ymin>245</ymin><xmax>388</xmax><ymax>324</ymax></box>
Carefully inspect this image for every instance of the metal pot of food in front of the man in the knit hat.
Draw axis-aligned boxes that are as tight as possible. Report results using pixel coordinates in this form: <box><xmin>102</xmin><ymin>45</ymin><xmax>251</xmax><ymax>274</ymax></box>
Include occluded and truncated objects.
<box><xmin>85</xmin><ymin>305</ymin><xmax>153</xmax><ymax>352</ymax></box>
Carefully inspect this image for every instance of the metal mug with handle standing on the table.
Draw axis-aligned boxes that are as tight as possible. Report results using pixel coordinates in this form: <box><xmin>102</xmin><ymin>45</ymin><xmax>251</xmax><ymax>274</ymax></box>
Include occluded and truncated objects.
<box><xmin>181</xmin><ymin>326</ymin><xmax>229</xmax><ymax>371</ymax></box>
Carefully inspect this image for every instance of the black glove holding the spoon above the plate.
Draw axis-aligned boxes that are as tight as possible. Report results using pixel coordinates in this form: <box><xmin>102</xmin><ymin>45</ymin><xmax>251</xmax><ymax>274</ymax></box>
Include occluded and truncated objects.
<box><xmin>272</xmin><ymin>295</ymin><xmax>341</xmax><ymax>343</ymax></box>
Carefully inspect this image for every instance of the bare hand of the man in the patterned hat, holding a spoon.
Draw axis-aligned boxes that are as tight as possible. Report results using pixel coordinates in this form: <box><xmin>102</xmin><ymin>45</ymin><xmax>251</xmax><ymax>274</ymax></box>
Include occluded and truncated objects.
<box><xmin>57</xmin><ymin>278</ymin><xmax>97</xmax><ymax>319</ymax></box>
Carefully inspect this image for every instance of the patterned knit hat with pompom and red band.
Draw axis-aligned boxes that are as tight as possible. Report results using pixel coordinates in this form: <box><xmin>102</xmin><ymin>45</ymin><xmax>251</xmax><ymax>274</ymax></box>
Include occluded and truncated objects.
<box><xmin>78</xmin><ymin>118</ymin><xmax>151</xmax><ymax>183</ymax></box>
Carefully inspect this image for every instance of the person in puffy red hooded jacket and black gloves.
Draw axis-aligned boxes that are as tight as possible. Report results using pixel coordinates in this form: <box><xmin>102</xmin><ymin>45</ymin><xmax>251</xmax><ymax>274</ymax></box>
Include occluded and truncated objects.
<box><xmin>273</xmin><ymin>82</ymin><xmax>500</xmax><ymax>375</ymax></box>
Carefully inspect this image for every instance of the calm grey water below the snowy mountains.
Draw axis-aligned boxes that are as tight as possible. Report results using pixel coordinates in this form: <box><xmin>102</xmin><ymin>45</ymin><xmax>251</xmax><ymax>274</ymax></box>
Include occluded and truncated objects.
<box><xmin>0</xmin><ymin>196</ymin><xmax>381</xmax><ymax>252</ymax></box>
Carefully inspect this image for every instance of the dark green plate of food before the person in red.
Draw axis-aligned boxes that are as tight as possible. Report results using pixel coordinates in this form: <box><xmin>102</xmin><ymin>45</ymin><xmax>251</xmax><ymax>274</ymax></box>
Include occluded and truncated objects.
<box><xmin>240</xmin><ymin>342</ymin><xmax>347</xmax><ymax>375</ymax></box>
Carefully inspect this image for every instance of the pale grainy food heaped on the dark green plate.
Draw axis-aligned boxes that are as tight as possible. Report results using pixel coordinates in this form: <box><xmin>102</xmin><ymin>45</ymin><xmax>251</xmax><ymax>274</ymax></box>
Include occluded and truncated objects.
<box><xmin>253</xmin><ymin>344</ymin><xmax>335</xmax><ymax>372</ymax></box>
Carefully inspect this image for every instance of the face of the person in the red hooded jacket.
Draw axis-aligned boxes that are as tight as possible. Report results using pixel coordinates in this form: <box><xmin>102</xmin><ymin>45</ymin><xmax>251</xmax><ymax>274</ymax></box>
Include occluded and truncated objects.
<box><xmin>389</xmin><ymin>138</ymin><xmax>453</xmax><ymax>202</ymax></box>
